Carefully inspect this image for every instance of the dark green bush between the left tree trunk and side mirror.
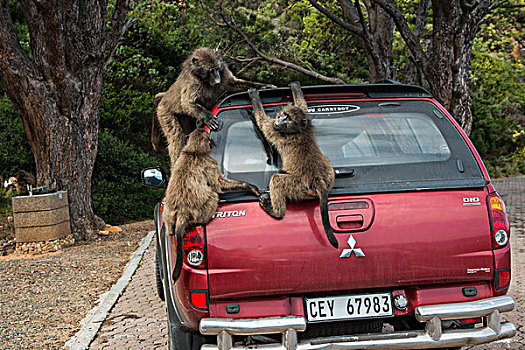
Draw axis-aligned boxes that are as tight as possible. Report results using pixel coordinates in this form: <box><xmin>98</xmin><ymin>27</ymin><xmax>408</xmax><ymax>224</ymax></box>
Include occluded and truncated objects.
<box><xmin>91</xmin><ymin>131</ymin><xmax>163</xmax><ymax>224</ymax></box>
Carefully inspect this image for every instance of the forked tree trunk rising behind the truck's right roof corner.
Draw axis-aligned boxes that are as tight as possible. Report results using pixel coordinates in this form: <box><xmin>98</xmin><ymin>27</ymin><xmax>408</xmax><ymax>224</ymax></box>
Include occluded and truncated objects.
<box><xmin>373</xmin><ymin>0</ymin><xmax>497</xmax><ymax>133</ymax></box>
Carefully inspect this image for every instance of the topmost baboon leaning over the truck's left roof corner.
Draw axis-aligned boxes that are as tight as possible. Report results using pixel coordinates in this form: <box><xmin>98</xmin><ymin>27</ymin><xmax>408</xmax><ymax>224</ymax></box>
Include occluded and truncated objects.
<box><xmin>151</xmin><ymin>47</ymin><xmax>275</xmax><ymax>163</ymax></box>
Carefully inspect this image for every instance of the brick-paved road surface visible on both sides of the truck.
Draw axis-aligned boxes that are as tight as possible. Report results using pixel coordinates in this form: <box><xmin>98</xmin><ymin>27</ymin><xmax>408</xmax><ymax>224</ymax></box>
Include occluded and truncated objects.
<box><xmin>90</xmin><ymin>177</ymin><xmax>525</xmax><ymax>350</ymax></box>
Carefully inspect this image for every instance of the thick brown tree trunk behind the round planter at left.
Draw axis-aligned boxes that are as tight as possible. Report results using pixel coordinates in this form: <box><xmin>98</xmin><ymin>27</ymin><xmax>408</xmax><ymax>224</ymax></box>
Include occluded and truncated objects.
<box><xmin>0</xmin><ymin>0</ymin><xmax>132</xmax><ymax>240</ymax></box>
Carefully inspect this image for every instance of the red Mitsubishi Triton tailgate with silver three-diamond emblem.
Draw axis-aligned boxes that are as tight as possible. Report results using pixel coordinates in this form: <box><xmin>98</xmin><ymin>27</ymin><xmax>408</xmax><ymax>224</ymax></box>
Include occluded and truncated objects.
<box><xmin>206</xmin><ymin>189</ymin><xmax>493</xmax><ymax>299</ymax></box>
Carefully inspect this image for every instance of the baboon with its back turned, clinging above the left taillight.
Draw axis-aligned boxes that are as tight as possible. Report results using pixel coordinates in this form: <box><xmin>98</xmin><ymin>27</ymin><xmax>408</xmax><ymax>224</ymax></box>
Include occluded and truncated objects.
<box><xmin>162</xmin><ymin>128</ymin><xmax>261</xmax><ymax>281</ymax></box>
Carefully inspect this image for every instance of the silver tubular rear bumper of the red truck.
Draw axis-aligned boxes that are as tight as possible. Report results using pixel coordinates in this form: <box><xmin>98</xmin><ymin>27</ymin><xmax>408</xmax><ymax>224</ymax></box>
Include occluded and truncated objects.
<box><xmin>199</xmin><ymin>296</ymin><xmax>516</xmax><ymax>350</ymax></box>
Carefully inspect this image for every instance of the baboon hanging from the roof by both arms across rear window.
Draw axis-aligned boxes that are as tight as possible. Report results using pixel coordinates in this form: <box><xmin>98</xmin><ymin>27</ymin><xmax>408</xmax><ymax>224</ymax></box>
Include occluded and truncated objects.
<box><xmin>248</xmin><ymin>82</ymin><xmax>339</xmax><ymax>248</ymax></box>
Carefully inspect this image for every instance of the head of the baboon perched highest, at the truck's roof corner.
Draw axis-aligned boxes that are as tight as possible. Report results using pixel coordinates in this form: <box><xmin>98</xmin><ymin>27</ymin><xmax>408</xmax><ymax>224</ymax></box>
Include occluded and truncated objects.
<box><xmin>191</xmin><ymin>47</ymin><xmax>224</xmax><ymax>86</ymax></box>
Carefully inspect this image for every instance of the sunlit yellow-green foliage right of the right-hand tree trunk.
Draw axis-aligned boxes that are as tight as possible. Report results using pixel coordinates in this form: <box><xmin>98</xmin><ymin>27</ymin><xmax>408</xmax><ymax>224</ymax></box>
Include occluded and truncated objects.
<box><xmin>470</xmin><ymin>0</ymin><xmax>525</xmax><ymax>177</ymax></box>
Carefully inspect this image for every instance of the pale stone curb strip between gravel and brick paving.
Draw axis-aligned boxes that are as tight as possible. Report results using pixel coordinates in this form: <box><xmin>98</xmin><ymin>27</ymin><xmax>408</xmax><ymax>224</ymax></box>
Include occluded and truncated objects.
<box><xmin>63</xmin><ymin>231</ymin><xmax>155</xmax><ymax>350</ymax></box>
